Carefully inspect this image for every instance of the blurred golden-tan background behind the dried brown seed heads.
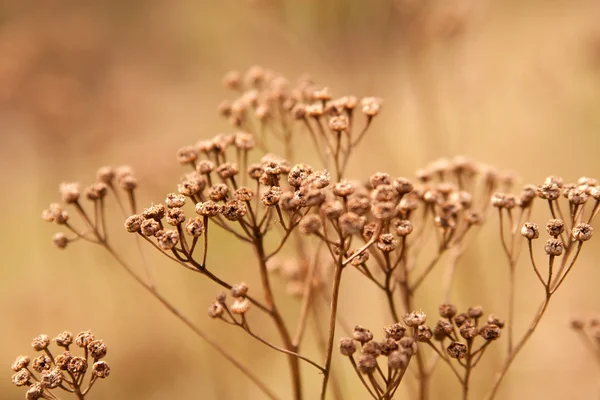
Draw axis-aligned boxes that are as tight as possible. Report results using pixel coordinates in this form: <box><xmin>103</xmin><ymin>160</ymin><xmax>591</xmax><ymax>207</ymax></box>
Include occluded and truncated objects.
<box><xmin>0</xmin><ymin>0</ymin><xmax>600</xmax><ymax>399</ymax></box>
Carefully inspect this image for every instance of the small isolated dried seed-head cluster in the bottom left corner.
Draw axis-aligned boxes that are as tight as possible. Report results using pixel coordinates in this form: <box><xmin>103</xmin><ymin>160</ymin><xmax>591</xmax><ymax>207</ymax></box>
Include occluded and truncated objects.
<box><xmin>12</xmin><ymin>331</ymin><xmax>110</xmax><ymax>400</ymax></box>
